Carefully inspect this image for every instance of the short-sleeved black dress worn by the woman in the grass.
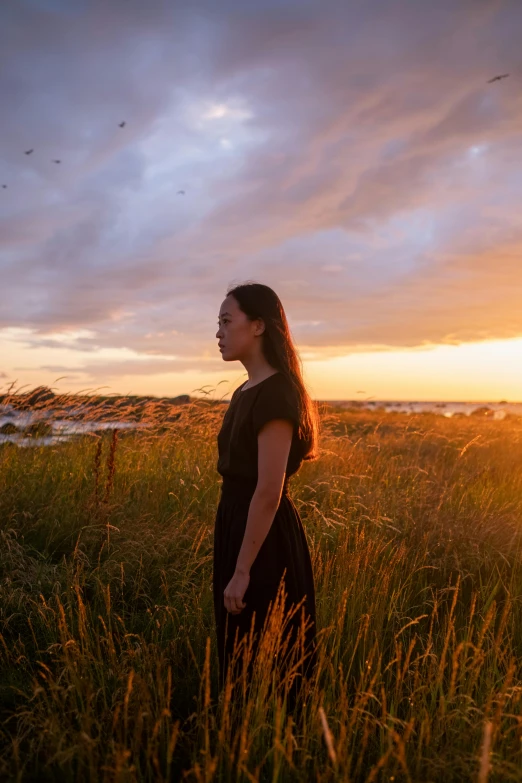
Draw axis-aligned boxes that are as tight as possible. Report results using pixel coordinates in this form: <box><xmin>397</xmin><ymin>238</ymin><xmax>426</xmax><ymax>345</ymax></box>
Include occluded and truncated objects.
<box><xmin>213</xmin><ymin>372</ymin><xmax>316</xmax><ymax>696</ymax></box>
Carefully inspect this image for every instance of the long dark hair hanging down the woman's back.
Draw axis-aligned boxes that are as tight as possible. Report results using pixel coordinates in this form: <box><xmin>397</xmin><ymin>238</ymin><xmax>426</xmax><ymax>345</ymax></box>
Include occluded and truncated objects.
<box><xmin>227</xmin><ymin>283</ymin><xmax>319</xmax><ymax>460</ymax></box>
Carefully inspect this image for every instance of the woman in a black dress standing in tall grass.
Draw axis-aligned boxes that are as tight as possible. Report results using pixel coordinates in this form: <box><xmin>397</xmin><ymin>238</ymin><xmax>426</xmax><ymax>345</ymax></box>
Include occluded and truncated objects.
<box><xmin>213</xmin><ymin>283</ymin><xmax>318</xmax><ymax>710</ymax></box>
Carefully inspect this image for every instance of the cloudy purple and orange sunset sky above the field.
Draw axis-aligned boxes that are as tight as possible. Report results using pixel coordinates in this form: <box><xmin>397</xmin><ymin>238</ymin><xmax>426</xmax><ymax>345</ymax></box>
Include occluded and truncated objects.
<box><xmin>0</xmin><ymin>0</ymin><xmax>522</xmax><ymax>401</ymax></box>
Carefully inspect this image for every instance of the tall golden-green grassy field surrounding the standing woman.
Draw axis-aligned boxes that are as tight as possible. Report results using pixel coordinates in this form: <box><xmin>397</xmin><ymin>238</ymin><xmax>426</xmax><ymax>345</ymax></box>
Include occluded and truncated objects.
<box><xmin>0</xmin><ymin>403</ymin><xmax>522</xmax><ymax>783</ymax></box>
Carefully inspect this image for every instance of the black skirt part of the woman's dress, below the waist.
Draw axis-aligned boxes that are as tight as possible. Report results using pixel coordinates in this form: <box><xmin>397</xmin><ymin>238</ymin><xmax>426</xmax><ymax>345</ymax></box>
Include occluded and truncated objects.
<box><xmin>213</xmin><ymin>476</ymin><xmax>316</xmax><ymax>700</ymax></box>
